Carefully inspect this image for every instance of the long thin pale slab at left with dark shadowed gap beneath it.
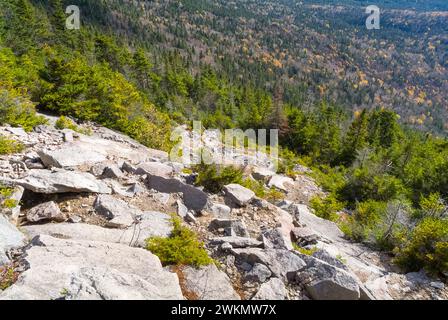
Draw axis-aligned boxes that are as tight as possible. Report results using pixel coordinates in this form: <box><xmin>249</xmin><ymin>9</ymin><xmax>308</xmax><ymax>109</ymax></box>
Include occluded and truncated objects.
<box><xmin>13</xmin><ymin>169</ymin><xmax>112</xmax><ymax>194</ymax></box>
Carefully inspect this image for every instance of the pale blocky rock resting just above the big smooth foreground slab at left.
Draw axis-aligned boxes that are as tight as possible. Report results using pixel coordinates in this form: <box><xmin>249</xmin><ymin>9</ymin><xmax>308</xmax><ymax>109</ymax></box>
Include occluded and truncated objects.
<box><xmin>94</xmin><ymin>194</ymin><xmax>142</xmax><ymax>228</ymax></box>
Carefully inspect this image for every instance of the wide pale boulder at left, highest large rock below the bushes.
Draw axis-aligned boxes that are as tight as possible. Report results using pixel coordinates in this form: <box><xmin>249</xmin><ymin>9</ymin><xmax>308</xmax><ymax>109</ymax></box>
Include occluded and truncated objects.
<box><xmin>37</xmin><ymin>144</ymin><xmax>107</xmax><ymax>168</ymax></box>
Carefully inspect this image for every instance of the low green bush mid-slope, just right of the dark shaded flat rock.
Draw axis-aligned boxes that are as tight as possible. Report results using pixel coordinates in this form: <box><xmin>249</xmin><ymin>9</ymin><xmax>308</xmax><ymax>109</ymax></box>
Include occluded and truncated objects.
<box><xmin>194</xmin><ymin>163</ymin><xmax>243</xmax><ymax>193</ymax></box>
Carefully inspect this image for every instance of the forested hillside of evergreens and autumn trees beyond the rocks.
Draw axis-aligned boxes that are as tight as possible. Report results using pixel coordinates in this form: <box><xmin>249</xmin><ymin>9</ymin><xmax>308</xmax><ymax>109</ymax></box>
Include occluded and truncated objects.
<box><xmin>0</xmin><ymin>0</ymin><xmax>448</xmax><ymax>273</ymax></box>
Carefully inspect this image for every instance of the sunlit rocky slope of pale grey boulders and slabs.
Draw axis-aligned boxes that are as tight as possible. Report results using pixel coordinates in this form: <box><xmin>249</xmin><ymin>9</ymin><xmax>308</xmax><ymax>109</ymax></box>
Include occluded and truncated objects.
<box><xmin>0</xmin><ymin>119</ymin><xmax>448</xmax><ymax>300</ymax></box>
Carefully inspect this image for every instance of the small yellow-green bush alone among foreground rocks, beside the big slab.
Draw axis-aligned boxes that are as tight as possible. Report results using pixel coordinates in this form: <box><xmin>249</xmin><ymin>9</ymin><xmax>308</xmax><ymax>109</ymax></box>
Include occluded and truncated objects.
<box><xmin>146</xmin><ymin>216</ymin><xmax>213</xmax><ymax>267</ymax></box>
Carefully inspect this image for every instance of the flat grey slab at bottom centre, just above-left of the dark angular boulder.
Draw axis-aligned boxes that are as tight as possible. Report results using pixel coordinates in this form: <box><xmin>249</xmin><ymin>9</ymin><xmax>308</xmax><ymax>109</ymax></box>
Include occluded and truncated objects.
<box><xmin>231</xmin><ymin>248</ymin><xmax>306</xmax><ymax>280</ymax></box>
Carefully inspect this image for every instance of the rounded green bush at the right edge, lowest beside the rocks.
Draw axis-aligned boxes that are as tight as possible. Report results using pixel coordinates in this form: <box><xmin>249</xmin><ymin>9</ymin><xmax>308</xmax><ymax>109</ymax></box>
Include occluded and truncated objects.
<box><xmin>395</xmin><ymin>218</ymin><xmax>448</xmax><ymax>275</ymax></box>
